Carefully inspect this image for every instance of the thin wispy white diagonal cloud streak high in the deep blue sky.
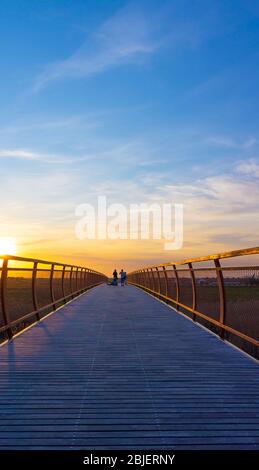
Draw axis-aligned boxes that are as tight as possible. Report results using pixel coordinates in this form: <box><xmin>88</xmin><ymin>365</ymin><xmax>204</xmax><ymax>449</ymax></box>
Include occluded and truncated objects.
<box><xmin>32</xmin><ymin>7</ymin><xmax>159</xmax><ymax>93</ymax></box>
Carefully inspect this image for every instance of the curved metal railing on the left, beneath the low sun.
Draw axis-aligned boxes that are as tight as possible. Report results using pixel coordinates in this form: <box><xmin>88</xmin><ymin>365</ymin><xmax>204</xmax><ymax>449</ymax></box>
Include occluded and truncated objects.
<box><xmin>0</xmin><ymin>256</ymin><xmax>107</xmax><ymax>341</ymax></box>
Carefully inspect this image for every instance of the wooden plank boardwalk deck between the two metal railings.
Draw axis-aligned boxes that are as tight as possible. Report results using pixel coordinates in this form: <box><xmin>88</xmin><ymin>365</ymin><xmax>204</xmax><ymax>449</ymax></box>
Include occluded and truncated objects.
<box><xmin>0</xmin><ymin>286</ymin><xmax>259</xmax><ymax>450</ymax></box>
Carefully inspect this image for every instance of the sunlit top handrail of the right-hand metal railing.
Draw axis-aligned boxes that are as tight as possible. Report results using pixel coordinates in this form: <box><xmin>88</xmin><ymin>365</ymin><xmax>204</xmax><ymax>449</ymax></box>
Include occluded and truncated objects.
<box><xmin>129</xmin><ymin>246</ymin><xmax>259</xmax><ymax>274</ymax></box>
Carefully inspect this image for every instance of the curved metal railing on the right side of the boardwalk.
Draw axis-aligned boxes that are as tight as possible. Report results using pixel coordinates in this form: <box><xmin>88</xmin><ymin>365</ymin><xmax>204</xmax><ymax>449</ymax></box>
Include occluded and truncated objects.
<box><xmin>128</xmin><ymin>247</ymin><xmax>259</xmax><ymax>358</ymax></box>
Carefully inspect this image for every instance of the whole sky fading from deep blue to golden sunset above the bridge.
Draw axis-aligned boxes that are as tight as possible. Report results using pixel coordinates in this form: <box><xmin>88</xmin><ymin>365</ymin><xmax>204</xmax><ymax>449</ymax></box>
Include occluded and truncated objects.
<box><xmin>0</xmin><ymin>0</ymin><xmax>259</xmax><ymax>272</ymax></box>
